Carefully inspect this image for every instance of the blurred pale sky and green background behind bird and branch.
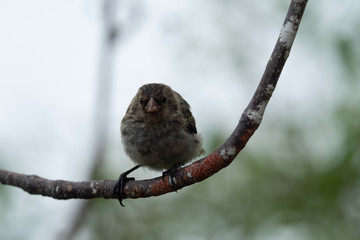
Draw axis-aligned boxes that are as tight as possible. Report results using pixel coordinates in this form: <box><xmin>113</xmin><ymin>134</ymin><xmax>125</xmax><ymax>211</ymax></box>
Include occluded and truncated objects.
<box><xmin>0</xmin><ymin>0</ymin><xmax>360</xmax><ymax>240</ymax></box>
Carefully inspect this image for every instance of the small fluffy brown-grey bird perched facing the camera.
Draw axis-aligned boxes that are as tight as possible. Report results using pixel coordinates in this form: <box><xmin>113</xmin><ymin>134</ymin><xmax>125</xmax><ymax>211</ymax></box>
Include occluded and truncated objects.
<box><xmin>114</xmin><ymin>83</ymin><xmax>205</xmax><ymax>206</ymax></box>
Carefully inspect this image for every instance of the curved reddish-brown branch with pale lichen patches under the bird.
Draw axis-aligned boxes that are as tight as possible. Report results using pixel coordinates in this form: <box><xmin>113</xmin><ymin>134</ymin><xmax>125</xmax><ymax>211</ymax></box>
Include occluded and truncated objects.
<box><xmin>0</xmin><ymin>0</ymin><xmax>307</xmax><ymax>202</ymax></box>
